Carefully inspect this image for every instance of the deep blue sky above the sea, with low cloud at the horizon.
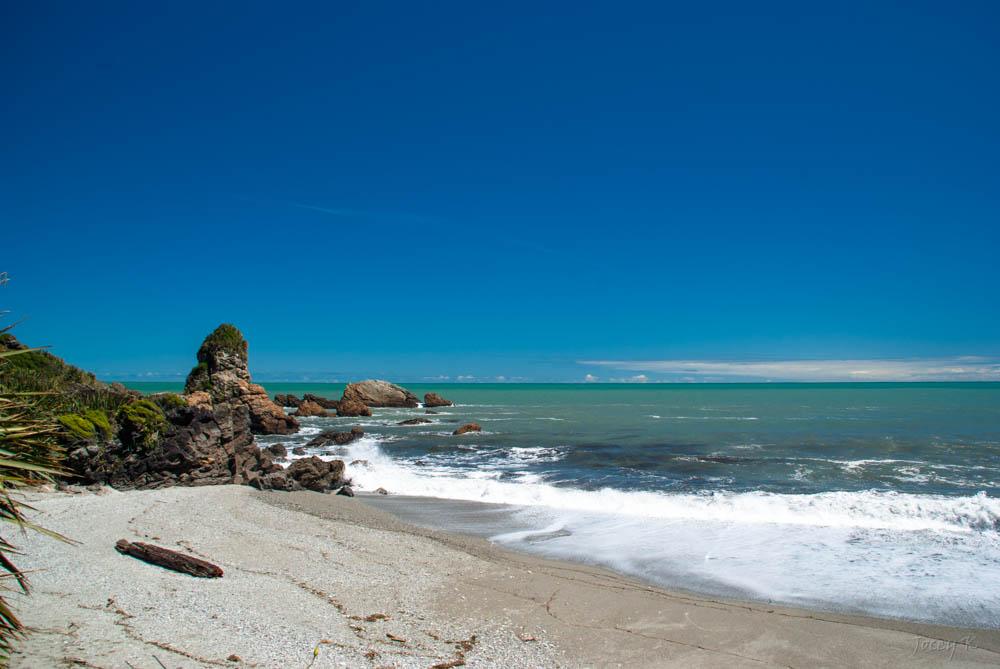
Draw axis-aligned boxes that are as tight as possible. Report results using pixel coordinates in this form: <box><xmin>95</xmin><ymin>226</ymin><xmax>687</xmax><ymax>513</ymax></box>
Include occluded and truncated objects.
<box><xmin>0</xmin><ymin>2</ymin><xmax>1000</xmax><ymax>381</ymax></box>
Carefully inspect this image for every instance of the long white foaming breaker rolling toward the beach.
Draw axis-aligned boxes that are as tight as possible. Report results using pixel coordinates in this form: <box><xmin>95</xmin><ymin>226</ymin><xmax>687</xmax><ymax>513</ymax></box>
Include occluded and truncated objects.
<box><xmin>346</xmin><ymin>438</ymin><xmax>1000</xmax><ymax>532</ymax></box>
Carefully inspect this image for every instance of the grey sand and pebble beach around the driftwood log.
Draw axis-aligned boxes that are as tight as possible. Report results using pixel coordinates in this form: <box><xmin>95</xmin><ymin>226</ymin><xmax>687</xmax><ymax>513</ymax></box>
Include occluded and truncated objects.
<box><xmin>12</xmin><ymin>485</ymin><xmax>1000</xmax><ymax>669</ymax></box>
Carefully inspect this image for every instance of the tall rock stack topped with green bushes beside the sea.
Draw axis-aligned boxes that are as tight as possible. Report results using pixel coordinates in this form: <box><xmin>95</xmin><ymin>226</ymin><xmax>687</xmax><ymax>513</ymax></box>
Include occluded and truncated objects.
<box><xmin>184</xmin><ymin>323</ymin><xmax>299</xmax><ymax>434</ymax></box>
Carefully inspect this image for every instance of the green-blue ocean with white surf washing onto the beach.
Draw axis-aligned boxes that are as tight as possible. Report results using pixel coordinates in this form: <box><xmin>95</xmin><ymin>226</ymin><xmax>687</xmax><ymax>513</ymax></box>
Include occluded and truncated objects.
<box><xmin>132</xmin><ymin>383</ymin><xmax>1000</xmax><ymax>628</ymax></box>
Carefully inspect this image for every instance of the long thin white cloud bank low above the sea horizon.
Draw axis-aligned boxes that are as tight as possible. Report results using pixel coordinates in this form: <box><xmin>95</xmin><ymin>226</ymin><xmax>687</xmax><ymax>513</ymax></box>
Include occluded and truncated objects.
<box><xmin>578</xmin><ymin>356</ymin><xmax>1000</xmax><ymax>381</ymax></box>
